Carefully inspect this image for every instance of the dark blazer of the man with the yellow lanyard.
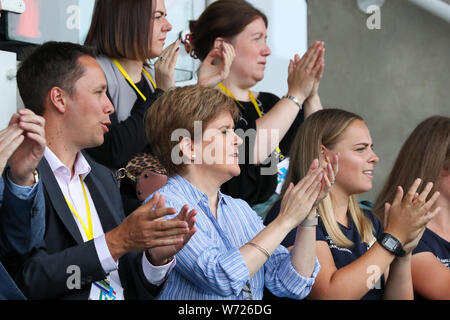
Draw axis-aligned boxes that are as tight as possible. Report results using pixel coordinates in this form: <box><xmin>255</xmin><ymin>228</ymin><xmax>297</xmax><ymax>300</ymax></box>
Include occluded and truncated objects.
<box><xmin>16</xmin><ymin>154</ymin><xmax>161</xmax><ymax>300</ymax></box>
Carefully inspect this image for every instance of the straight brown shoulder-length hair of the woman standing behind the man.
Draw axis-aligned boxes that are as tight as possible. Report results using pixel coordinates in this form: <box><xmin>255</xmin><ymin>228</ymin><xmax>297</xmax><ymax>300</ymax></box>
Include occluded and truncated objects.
<box><xmin>84</xmin><ymin>0</ymin><xmax>155</xmax><ymax>61</ymax></box>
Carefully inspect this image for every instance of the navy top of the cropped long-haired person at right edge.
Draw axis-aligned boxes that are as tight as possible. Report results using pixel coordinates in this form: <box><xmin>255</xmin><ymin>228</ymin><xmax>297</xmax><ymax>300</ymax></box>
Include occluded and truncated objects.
<box><xmin>413</xmin><ymin>228</ymin><xmax>450</xmax><ymax>300</ymax></box>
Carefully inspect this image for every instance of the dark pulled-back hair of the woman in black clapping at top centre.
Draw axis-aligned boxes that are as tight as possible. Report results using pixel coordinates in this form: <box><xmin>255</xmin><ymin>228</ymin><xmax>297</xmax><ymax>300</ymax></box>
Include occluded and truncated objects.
<box><xmin>189</xmin><ymin>0</ymin><xmax>268</xmax><ymax>61</ymax></box>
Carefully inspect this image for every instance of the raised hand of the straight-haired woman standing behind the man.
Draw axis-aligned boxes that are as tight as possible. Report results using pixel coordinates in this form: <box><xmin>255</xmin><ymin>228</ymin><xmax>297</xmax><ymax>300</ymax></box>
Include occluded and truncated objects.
<box><xmin>155</xmin><ymin>40</ymin><xmax>181</xmax><ymax>91</ymax></box>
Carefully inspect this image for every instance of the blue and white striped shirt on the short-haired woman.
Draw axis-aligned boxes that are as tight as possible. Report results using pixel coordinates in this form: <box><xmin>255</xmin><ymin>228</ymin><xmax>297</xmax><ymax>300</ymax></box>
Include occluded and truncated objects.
<box><xmin>146</xmin><ymin>176</ymin><xmax>320</xmax><ymax>300</ymax></box>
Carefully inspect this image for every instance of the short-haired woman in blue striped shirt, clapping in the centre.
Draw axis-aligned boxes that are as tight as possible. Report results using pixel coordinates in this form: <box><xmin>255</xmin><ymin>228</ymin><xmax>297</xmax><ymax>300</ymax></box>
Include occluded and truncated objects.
<box><xmin>142</xmin><ymin>86</ymin><xmax>334</xmax><ymax>300</ymax></box>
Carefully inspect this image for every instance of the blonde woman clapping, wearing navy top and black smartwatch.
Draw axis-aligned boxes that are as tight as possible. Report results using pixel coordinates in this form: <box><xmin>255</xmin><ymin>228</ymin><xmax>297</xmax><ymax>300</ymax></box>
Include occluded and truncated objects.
<box><xmin>271</xmin><ymin>109</ymin><xmax>439</xmax><ymax>300</ymax></box>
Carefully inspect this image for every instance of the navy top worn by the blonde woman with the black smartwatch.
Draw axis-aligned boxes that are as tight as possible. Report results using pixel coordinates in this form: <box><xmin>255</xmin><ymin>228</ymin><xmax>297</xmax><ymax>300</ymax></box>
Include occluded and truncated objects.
<box><xmin>264</xmin><ymin>200</ymin><xmax>384</xmax><ymax>300</ymax></box>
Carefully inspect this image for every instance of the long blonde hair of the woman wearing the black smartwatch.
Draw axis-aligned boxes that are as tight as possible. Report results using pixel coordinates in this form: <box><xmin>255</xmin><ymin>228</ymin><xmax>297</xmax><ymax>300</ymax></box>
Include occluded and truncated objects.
<box><xmin>281</xmin><ymin>109</ymin><xmax>374</xmax><ymax>247</ymax></box>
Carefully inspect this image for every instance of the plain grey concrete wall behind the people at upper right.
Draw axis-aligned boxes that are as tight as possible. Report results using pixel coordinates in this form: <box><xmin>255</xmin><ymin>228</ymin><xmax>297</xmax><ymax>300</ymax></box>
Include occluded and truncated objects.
<box><xmin>308</xmin><ymin>0</ymin><xmax>450</xmax><ymax>201</ymax></box>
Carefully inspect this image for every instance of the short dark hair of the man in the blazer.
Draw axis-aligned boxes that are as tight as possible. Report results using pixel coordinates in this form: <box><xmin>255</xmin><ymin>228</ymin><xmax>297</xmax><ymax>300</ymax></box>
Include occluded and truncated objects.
<box><xmin>17</xmin><ymin>41</ymin><xmax>94</xmax><ymax>115</ymax></box>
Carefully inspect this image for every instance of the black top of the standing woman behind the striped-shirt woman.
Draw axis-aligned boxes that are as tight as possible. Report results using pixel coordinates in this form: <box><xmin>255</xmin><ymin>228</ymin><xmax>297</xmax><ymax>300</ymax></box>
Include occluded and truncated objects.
<box><xmin>221</xmin><ymin>92</ymin><xmax>304</xmax><ymax>206</ymax></box>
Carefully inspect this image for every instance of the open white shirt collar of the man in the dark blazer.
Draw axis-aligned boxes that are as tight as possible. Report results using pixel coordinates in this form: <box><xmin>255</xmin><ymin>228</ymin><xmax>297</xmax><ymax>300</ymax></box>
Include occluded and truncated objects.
<box><xmin>44</xmin><ymin>147</ymin><xmax>91</xmax><ymax>184</ymax></box>
